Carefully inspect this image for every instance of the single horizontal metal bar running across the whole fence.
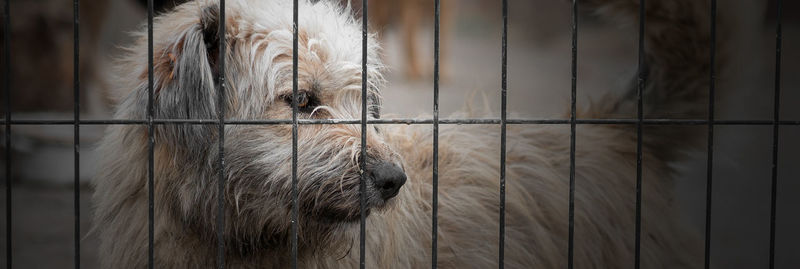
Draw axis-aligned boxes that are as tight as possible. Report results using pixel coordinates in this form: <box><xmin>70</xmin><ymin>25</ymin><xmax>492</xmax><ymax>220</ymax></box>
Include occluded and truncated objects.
<box><xmin>0</xmin><ymin>119</ymin><xmax>800</xmax><ymax>126</ymax></box>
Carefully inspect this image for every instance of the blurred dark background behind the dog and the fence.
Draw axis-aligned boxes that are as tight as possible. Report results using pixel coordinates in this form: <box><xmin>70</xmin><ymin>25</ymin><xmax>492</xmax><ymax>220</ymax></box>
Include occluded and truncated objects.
<box><xmin>0</xmin><ymin>0</ymin><xmax>800</xmax><ymax>268</ymax></box>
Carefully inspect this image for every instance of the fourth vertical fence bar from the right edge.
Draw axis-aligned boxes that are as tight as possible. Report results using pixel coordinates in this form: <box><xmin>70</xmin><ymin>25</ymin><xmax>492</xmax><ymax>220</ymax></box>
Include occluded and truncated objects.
<box><xmin>567</xmin><ymin>0</ymin><xmax>578</xmax><ymax>269</ymax></box>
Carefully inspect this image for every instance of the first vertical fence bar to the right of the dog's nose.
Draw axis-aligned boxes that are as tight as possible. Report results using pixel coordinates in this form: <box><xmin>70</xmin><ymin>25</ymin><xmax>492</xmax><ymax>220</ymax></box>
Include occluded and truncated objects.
<box><xmin>431</xmin><ymin>0</ymin><xmax>441</xmax><ymax>269</ymax></box>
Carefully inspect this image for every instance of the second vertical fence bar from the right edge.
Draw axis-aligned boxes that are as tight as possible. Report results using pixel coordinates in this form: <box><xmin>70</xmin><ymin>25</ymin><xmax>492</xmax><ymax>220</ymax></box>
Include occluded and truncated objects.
<box><xmin>705</xmin><ymin>0</ymin><xmax>717</xmax><ymax>269</ymax></box>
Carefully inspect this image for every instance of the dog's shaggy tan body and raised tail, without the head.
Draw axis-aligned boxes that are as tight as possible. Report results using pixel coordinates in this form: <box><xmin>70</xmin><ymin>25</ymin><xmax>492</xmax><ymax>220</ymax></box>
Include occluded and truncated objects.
<box><xmin>387</xmin><ymin>0</ymin><xmax>729</xmax><ymax>268</ymax></box>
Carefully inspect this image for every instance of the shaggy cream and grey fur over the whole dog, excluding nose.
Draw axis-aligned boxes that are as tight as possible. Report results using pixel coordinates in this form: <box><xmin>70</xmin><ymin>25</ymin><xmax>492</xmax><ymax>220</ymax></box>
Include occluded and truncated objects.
<box><xmin>94</xmin><ymin>0</ymin><xmax>724</xmax><ymax>268</ymax></box>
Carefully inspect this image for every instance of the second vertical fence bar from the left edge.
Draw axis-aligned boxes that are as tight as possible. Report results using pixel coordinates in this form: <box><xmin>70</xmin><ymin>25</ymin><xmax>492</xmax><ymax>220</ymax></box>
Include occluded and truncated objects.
<box><xmin>72</xmin><ymin>0</ymin><xmax>81</xmax><ymax>269</ymax></box>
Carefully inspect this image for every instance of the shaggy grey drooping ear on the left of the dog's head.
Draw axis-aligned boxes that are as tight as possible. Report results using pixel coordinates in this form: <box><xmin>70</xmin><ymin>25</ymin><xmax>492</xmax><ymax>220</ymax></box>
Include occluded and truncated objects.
<box><xmin>154</xmin><ymin>5</ymin><xmax>227</xmax><ymax>151</ymax></box>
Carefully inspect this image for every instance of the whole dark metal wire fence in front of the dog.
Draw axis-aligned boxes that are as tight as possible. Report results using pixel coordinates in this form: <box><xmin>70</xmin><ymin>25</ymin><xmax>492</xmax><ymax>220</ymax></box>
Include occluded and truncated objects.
<box><xmin>3</xmin><ymin>0</ymin><xmax>800</xmax><ymax>268</ymax></box>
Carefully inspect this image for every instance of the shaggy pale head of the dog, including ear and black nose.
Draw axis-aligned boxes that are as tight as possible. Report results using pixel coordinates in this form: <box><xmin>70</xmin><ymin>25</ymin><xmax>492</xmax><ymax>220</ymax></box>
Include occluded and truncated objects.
<box><xmin>112</xmin><ymin>0</ymin><xmax>406</xmax><ymax>251</ymax></box>
